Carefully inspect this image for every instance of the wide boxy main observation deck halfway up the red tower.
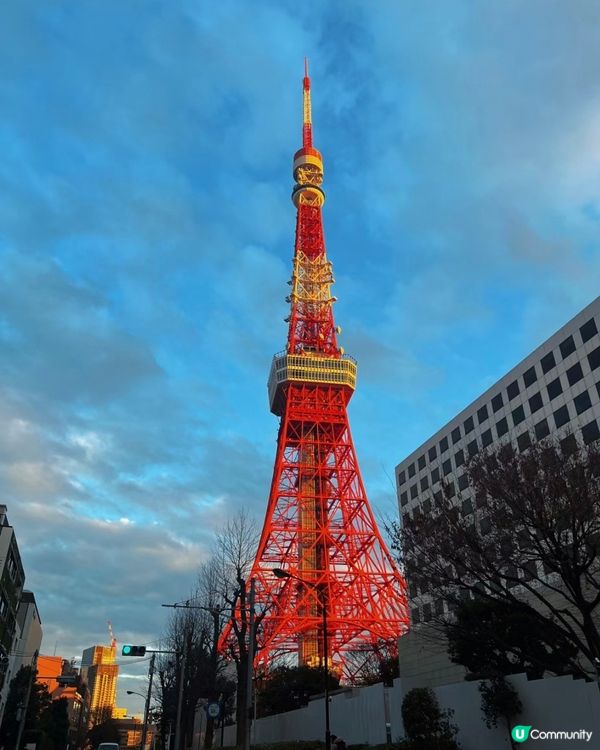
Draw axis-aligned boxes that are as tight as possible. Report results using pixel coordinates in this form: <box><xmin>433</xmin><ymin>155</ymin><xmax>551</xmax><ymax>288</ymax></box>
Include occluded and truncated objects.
<box><xmin>268</xmin><ymin>352</ymin><xmax>357</xmax><ymax>416</ymax></box>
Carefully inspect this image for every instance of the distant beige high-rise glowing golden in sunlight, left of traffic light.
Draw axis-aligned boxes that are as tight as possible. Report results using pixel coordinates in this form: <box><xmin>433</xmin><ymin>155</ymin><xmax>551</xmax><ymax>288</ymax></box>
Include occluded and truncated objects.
<box><xmin>81</xmin><ymin>646</ymin><xmax>119</xmax><ymax>725</ymax></box>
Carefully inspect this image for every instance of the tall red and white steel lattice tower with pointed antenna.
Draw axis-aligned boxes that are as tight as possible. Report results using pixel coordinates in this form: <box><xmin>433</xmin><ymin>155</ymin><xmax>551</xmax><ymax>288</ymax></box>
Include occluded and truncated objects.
<box><xmin>221</xmin><ymin>66</ymin><xmax>409</xmax><ymax>680</ymax></box>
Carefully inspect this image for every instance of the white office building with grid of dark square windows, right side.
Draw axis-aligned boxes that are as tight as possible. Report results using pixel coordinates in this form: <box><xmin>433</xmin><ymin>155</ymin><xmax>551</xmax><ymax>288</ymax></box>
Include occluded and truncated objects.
<box><xmin>396</xmin><ymin>297</ymin><xmax>600</xmax><ymax>685</ymax></box>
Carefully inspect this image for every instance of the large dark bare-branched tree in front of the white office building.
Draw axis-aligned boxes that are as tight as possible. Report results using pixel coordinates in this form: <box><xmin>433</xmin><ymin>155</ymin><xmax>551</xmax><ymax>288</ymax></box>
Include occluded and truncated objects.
<box><xmin>392</xmin><ymin>438</ymin><xmax>600</xmax><ymax>678</ymax></box>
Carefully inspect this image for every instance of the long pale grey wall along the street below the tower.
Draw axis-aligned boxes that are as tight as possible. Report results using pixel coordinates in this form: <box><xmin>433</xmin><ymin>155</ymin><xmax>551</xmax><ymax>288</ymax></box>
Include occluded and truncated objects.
<box><xmin>224</xmin><ymin>675</ymin><xmax>600</xmax><ymax>750</ymax></box>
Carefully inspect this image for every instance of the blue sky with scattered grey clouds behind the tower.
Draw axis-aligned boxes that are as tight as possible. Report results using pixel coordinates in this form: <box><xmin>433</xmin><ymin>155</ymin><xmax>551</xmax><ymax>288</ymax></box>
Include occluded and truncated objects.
<box><xmin>0</xmin><ymin>0</ymin><xmax>600</xmax><ymax>710</ymax></box>
